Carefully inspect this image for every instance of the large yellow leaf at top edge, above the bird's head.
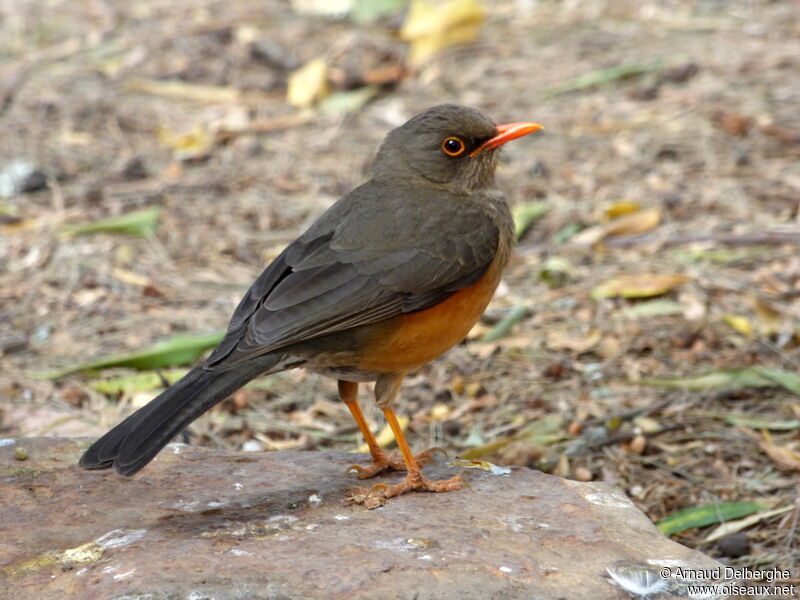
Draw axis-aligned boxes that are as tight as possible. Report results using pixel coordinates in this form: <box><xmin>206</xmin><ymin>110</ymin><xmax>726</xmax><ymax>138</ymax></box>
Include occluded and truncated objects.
<box><xmin>400</xmin><ymin>0</ymin><xmax>484</xmax><ymax>66</ymax></box>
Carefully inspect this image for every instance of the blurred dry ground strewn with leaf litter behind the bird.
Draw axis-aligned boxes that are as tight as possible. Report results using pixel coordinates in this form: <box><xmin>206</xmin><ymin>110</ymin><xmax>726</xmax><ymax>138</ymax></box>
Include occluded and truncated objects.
<box><xmin>0</xmin><ymin>0</ymin><xmax>800</xmax><ymax>584</ymax></box>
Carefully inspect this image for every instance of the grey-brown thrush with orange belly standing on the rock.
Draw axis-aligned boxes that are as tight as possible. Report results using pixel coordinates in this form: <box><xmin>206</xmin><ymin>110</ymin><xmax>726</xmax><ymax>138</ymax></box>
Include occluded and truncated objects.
<box><xmin>79</xmin><ymin>104</ymin><xmax>542</xmax><ymax>505</ymax></box>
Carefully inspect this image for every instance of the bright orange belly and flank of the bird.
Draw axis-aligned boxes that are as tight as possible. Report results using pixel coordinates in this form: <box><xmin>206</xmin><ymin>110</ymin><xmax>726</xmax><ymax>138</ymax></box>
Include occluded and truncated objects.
<box><xmin>357</xmin><ymin>260</ymin><xmax>505</xmax><ymax>373</ymax></box>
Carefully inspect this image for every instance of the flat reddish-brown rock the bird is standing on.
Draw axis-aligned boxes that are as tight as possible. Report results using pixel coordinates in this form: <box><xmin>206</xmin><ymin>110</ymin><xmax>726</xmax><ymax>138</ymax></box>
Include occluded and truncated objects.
<box><xmin>0</xmin><ymin>438</ymin><xmax>718</xmax><ymax>600</ymax></box>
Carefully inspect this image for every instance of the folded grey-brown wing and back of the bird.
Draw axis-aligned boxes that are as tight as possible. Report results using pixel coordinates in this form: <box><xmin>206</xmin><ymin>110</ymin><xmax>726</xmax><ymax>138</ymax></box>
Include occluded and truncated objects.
<box><xmin>205</xmin><ymin>184</ymin><xmax>499</xmax><ymax>369</ymax></box>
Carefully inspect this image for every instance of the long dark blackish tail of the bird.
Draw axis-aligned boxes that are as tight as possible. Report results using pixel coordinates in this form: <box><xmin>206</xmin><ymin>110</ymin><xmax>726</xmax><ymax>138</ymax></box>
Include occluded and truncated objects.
<box><xmin>79</xmin><ymin>354</ymin><xmax>281</xmax><ymax>475</ymax></box>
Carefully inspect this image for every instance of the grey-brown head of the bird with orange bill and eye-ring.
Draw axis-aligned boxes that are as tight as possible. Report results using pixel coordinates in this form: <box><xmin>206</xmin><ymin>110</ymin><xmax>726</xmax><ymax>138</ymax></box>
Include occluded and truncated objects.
<box><xmin>374</xmin><ymin>104</ymin><xmax>542</xmax><ymax>191</ymax></box>
